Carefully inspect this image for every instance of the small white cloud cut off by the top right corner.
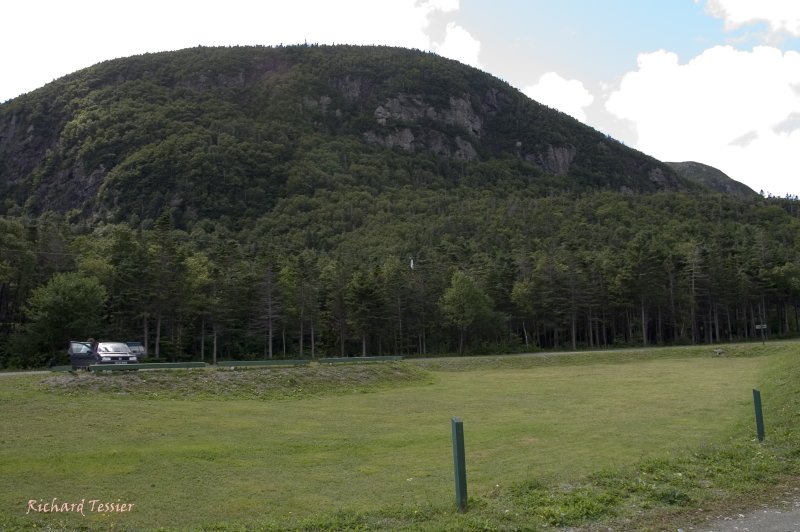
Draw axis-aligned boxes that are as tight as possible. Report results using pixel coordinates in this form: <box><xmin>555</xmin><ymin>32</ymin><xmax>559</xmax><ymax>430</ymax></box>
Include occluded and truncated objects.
<box><xmin>695</xmin><ymin>0</ymin><xmax>800</xmax><ymax>36</ymax></box>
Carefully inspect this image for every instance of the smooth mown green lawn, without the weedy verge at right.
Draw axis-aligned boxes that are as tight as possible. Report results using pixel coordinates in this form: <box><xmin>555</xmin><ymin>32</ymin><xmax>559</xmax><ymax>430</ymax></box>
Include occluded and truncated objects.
<box><xmin>0</xmin><ymin>342</ymin><xmax>780</xmax><ymax>528</ymax></box>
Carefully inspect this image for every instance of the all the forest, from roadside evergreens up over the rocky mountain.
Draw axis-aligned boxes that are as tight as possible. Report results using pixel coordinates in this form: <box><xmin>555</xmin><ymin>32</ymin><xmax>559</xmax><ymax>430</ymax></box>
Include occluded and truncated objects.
<box><xmin>0</xmin><ymin>46</ymin><xmax>800</xmax><ymax>367</ymax></box>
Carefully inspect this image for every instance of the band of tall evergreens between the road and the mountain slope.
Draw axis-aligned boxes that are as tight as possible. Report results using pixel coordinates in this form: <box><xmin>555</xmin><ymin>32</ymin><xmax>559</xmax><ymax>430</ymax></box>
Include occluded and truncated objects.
<box><xmin>0</xmin><ymin>188</ymin><xmax>800</xmax><ymax>367</ymax></box>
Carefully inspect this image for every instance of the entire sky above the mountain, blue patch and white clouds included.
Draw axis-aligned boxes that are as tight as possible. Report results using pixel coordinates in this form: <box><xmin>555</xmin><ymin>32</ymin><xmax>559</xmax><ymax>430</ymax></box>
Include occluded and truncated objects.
<box><xmin>0</xmin><ymin>0</ymin><xmax>800</xmax><ymax>196</ymax></box>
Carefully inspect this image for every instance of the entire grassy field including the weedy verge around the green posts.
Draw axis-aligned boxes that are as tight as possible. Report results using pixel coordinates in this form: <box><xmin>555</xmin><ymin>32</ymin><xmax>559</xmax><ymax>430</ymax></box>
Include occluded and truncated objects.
<box><xmin>0</xmin><ymin>343</ymin><xmax>799</xmax><ymax>529</ymax></box>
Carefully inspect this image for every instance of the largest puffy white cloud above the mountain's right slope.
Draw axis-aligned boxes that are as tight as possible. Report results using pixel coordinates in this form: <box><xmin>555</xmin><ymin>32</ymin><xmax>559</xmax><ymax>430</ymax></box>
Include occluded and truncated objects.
<box><xmin>606</xmin><ymin>46</ymin><xmax>800</xmax><ymax>195</ymax></box>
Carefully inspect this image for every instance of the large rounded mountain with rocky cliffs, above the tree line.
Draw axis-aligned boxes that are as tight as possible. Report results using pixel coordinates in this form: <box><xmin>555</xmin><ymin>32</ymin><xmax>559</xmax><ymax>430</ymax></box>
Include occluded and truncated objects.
<box><xmin>0</xmin><ymin>46</ymin><xmax>697</xmax><ymax>226</ymax></box>
